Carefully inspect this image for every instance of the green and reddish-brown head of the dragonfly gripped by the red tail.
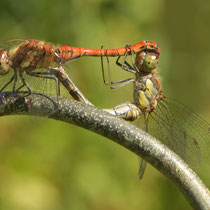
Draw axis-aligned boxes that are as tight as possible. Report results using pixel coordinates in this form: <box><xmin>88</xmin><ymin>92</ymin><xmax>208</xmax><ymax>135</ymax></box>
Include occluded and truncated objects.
<box><xmin>135</xmin><ymin>51</ymin><xmax>159</xmax><ymax>73</ymax></box>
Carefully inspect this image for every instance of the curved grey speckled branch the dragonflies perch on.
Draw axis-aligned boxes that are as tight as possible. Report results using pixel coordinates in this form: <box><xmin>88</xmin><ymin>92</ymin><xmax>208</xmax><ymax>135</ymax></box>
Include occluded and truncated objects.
<box><xmin>0</xmin><ymin>93</ymin><xmax>210</xmax><ymax>209</ymax></box>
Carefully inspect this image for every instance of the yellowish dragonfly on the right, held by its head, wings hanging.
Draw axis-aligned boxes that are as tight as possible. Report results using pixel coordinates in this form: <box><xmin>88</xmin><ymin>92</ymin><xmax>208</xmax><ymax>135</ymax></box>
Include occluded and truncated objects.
<box><xmin>102</xmin><ymin>47</ymin><xmax>210</xmax><ymax>179</ymax></box>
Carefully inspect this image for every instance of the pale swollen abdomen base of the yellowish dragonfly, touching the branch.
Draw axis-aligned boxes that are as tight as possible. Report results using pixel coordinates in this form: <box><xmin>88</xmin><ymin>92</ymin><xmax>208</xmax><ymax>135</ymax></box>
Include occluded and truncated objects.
<box><xmin>104</xmin><ymin>102</ymin><xmax>141</xmax><ymax>121</ymax></box>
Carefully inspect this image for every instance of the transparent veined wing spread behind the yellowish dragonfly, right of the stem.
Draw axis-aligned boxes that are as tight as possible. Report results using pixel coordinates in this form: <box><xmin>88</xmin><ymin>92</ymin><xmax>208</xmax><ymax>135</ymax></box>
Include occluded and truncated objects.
<box><xmin>139</xmin><ymin>98</ymin><xmax>210</xmax><ymax>167</ymax></box>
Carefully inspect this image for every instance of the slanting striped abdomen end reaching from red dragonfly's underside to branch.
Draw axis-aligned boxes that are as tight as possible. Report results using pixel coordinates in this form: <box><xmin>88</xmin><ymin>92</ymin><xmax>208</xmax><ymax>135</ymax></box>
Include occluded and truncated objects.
<box><xmin>49</xmin><ymin>66</ymin><xmax>93</xmax><ymax>106</ymax></box>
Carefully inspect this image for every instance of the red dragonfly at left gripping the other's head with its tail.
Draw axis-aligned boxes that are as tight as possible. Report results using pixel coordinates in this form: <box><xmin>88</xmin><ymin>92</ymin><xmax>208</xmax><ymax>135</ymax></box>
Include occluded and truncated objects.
<box><xmin>0</xmin><ymin>40</ymin><xmax>160</xmax><ymax>104</ymax></box>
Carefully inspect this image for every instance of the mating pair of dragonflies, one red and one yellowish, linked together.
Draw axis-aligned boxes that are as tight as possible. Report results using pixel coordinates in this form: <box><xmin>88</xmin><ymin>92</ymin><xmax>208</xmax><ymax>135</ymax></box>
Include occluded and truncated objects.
<box><xmin>0</xmin><ymin>40</ymin><xmax>210</xmax><ymax>178</ymax></box>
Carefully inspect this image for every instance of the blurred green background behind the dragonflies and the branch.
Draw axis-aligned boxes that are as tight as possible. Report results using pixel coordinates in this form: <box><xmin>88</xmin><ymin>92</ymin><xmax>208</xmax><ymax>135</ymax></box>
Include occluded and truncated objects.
<box><xmin>0</xmin><ymin>0</ymin><xmax>210</xmax><ymax>210</ymax></box>
